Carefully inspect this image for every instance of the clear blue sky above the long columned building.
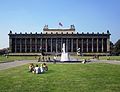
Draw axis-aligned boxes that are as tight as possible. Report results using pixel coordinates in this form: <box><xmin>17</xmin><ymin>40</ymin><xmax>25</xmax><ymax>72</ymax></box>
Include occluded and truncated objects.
<box><xmin>0</xmin><ymin>0</ymin><xmax>120</xmax><ymax>48</ymax></box>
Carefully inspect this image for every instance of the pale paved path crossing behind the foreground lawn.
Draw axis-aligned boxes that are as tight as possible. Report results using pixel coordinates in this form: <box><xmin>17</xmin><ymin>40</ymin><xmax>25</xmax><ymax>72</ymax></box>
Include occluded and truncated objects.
<box><xmin>0</xmin><ymin>59</ymin><xmax>120</xmax><ymax>70</ymax></box>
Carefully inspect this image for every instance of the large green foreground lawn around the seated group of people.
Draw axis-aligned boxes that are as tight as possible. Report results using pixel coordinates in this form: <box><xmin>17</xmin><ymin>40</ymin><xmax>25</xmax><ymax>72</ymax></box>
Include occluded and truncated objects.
<box><xmin>0</xmin><ymin>63</ymin><xmax>120</xmax><ymax>92</ymax></box>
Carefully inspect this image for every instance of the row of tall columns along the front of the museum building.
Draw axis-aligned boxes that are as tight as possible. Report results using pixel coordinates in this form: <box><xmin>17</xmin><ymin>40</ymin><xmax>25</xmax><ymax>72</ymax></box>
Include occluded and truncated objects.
<box><xmin>10</xmin><ymin>38</ymin><xmax>110</xmax><ymax>53</ymax></box>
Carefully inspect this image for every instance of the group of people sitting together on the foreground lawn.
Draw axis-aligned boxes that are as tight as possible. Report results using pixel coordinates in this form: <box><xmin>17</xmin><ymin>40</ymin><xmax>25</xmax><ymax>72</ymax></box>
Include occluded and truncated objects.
<box><xmin>29</xmin><ymin>63</ymin><xmax>48</xmax><ymax>74</ymax></box>
